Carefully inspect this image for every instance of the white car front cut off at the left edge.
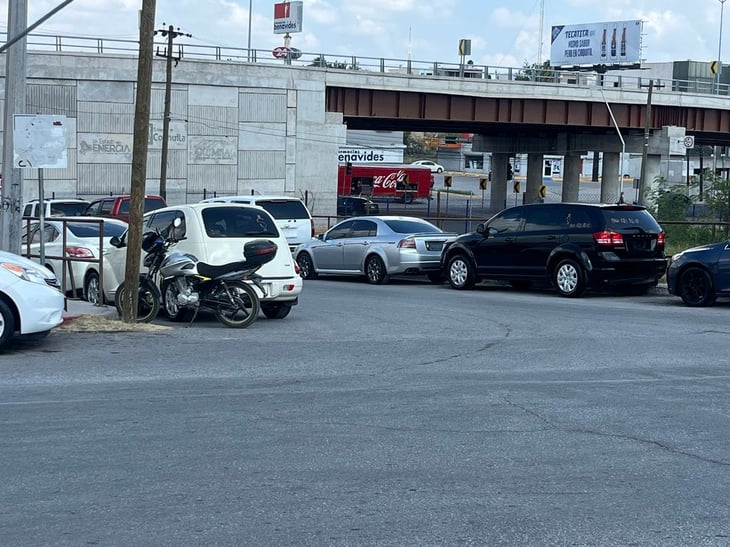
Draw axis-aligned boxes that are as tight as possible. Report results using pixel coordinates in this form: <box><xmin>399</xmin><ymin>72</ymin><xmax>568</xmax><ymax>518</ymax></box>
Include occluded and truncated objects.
<box><xmin>0</xmin><ymin>251</ymin><xmax>65</xmax><ymax>349</ymax></box>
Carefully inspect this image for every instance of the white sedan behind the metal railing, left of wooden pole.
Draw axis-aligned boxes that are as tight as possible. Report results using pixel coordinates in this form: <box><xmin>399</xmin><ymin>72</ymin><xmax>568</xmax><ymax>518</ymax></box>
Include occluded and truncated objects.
<box><xmin>22</xmin><ymin>217</ymin><xmax>127</xmax><ymax>304</ymax></box>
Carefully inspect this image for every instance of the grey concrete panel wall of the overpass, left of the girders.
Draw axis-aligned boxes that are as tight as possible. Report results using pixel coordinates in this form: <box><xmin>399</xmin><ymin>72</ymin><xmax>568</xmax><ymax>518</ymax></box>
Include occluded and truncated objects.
<box><xmin>0</xmin><ymin>53</ymin><xmax>346</xmax><ymax>223</ymax></box>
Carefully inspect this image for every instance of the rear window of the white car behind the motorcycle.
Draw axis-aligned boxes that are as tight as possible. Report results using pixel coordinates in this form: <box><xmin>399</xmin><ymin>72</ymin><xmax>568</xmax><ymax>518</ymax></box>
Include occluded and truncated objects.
<box><xmin>201</xmin><ymin>207</ymin><xmax>279</xmax><ymax>238</ymax></box>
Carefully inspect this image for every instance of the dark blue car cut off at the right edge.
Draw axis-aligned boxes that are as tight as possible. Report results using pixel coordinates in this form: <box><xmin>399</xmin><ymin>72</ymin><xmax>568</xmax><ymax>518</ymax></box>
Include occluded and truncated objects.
<box><xmin>667</xmin><ymin>240</ymin><xmax>730</xmax><ymax>306</ymax></box>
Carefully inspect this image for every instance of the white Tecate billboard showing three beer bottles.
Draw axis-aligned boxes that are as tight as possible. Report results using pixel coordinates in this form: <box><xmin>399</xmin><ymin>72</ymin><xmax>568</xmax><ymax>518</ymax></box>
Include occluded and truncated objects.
<box><xmin>550</xmin><ymin>20</ymin><xmax>641</xmax><ymax>67</ymax></box>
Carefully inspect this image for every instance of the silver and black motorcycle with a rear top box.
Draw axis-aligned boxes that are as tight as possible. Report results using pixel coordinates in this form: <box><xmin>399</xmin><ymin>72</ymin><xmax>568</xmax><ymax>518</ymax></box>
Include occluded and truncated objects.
<box><xmin>118</xmin><ymin>232</ymin><xmax>277</xmax><ymax>328</ymax></box>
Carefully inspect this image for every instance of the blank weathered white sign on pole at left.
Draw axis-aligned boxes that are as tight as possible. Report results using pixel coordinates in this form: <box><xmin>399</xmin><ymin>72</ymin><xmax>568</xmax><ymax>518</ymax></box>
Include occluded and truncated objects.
<box><xmin>13</xmin><ymin>114</ymin><xmax>68</xmax><ymax>169</ymax></box>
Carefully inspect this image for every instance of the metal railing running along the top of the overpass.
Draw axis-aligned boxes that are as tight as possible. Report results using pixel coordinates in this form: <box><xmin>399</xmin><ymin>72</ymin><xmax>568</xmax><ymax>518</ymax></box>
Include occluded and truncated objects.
<box><xmin>7</xmin><ymin>33</ymin><xmax>730</xmax><ymax>96</ymax></box>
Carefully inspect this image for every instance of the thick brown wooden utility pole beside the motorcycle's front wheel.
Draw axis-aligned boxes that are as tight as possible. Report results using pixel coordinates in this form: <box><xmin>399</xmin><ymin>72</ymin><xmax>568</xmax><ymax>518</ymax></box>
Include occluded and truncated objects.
<box><xmin>122</xmin><ymin>0</ymin><xmax>156</xmax><ymax>323</ymax></box>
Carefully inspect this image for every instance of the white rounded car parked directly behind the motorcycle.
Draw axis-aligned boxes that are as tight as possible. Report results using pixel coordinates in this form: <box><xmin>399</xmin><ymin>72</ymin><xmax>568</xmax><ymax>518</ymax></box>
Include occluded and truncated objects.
<box><xmin>105</xmin><ymin>203</ymin><xmax>302</xmax><ymax>319</ymax></box>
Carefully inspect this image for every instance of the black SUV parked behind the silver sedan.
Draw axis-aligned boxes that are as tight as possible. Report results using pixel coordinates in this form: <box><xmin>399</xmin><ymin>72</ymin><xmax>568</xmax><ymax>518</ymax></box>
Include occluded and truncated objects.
<box><xmin>441</xmin><ymin>203</ymin><xmax>667</xmax><ymax>296</ymax></box>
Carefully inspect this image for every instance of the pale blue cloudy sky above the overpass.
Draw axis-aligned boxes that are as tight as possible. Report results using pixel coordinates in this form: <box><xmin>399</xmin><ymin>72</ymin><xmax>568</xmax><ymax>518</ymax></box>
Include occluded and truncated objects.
<box><xmin>0</xmin><ymin>0</ymin><xmax>730</xmax><ymax>67</ymax></box>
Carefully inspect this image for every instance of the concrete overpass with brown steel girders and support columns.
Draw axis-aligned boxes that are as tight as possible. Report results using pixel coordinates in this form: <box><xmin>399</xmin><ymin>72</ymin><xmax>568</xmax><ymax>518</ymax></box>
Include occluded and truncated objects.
<box><xmin>5</xmin><ymin>33</ymin><xmax>730</xmax><ymax>215</ymax></box>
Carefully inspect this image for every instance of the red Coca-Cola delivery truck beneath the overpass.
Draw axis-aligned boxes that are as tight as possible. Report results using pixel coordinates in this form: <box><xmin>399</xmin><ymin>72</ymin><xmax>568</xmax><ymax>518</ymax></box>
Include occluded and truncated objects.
<box><xmin>337</xmin><ymin>164</ymin><xmax>433</xmax><ymax>203</ymax></box>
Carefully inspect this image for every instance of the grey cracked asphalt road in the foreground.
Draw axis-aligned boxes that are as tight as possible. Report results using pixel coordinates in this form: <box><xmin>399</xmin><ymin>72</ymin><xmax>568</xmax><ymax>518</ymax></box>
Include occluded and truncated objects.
<box><xmin>0</xmin><ymin>280</ymin><xmax>730</xmax><ymax>546</ymax></box>
